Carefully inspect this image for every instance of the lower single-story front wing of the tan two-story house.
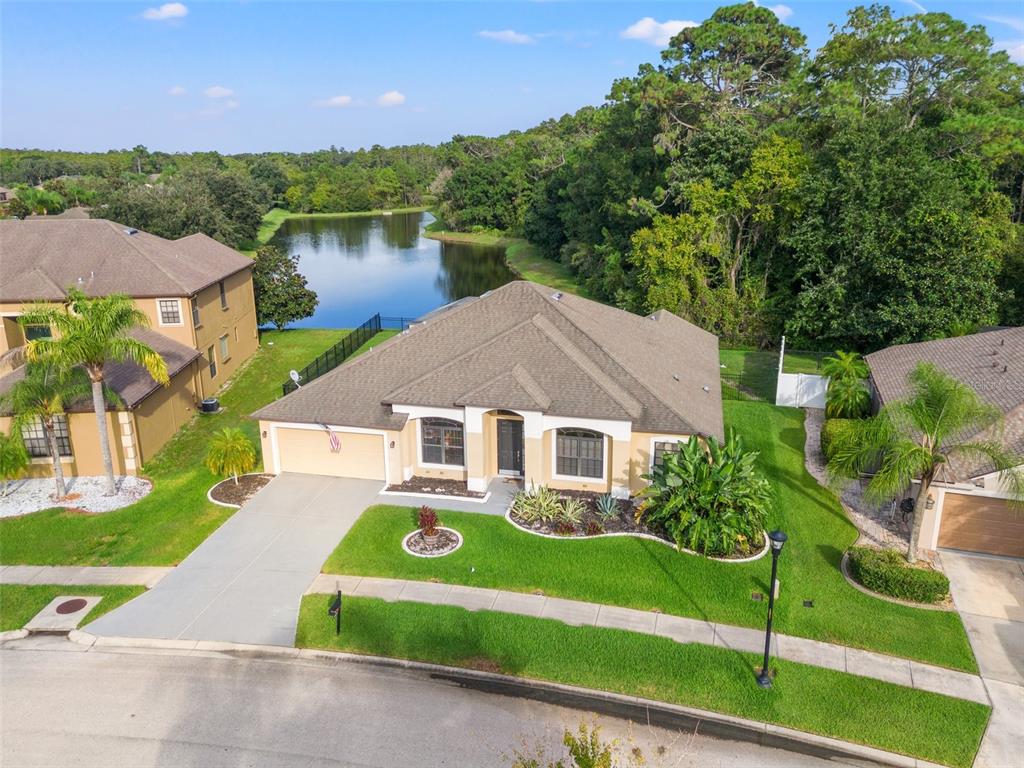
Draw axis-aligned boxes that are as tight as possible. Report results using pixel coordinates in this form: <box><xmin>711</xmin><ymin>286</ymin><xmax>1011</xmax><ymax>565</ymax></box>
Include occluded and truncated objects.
<box><xmin>0</xmin><ymin>329</ymin><xmax>202</xmax><ymax>477</ymax></box>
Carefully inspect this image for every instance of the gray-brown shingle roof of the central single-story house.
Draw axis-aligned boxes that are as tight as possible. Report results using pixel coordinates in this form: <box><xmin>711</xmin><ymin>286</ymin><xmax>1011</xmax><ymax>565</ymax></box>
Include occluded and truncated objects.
<box><xmin>255</xmin><ymin>281</ymin><xmax>724</xmax><ymax>436</ymax></box>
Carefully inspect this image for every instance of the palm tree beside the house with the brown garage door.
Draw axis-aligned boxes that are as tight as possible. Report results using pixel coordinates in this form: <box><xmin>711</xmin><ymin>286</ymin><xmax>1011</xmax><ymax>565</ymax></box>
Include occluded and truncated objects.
<box><xmin>828</xmin><ymin>362</ymin><xmax>1024</xmax><ymax>563</ymax></box>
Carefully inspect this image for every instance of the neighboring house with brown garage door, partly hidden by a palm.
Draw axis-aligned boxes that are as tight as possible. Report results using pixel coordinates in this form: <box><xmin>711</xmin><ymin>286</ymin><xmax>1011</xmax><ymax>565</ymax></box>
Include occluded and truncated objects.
<box><xmin>864</xmin><ymin>328</ymin><xmax>1024</xmax><ymax>557</ymax></box>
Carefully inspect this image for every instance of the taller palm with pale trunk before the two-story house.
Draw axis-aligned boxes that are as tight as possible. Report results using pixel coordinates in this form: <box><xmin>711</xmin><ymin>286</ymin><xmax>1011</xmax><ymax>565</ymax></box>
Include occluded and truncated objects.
<box><xmin>20</xmin><ymin>288</ymin><xmax>170</xmax><ymax>496</ymax></box>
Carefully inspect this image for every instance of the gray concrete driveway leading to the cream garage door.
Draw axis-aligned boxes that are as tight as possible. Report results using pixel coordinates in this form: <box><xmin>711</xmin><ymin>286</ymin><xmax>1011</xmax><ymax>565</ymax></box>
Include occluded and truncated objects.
<box><xmin>87</xmin><ymin>473</ymin><xmax>382</xmax><ymax>645</ymax></box>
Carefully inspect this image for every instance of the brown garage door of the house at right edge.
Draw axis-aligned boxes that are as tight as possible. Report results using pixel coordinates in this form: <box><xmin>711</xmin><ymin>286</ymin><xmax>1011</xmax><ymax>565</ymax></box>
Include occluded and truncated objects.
<box><xmin>939</xmin><ymin>493</ymin><xmax>1024</xmax><ymax>557</ymax></box>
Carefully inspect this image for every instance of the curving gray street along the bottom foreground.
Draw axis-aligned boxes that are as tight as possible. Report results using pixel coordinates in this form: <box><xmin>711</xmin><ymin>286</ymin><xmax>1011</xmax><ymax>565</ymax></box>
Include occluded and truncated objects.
<box><xmin>0</xmin><ymin>638</ymin><xmax>835</xmax><ymax>768</ymax></box>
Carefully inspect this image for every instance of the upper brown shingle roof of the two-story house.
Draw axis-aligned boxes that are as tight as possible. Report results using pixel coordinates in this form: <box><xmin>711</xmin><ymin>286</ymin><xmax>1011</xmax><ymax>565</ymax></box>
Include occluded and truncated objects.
<box><xmin>0</xmin><ymin>218</ymin><xmax>252</xmax><ymax>302</ymax></box>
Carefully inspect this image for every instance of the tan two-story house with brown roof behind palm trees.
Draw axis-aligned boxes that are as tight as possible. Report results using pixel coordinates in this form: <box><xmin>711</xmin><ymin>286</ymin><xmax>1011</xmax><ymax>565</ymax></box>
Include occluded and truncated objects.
<box><xmin>0</xmin><ymin>219</ymin><xmax>259</xmax><ymax>476</ymax></box>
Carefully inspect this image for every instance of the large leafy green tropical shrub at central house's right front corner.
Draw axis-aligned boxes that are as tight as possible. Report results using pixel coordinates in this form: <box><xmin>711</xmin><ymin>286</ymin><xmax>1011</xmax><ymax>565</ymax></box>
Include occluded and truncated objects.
<box><xmin>637</xmin><ymin>433</ymin><xmax>771</xmax><ymax>556</ymax></box>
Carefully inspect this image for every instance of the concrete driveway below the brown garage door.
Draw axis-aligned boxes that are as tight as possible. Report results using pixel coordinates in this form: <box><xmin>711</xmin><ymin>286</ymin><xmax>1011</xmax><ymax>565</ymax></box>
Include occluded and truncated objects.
<box><xmin>940</xmin><ymin>550</ymin><xmax>1024</xmax><ymax>768</ymax></box>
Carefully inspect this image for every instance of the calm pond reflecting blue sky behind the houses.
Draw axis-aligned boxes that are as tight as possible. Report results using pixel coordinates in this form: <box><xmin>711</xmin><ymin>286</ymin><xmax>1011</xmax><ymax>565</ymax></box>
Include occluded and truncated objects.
<box><xmin>270</xmin><ymin>212</ymin><xmax>515</xmax><ymax>328</ymax></box>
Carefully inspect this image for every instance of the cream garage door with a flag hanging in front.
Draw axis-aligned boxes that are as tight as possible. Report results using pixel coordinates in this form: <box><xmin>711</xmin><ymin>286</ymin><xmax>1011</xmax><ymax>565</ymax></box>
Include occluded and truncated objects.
<box><xmin>278</xmin><ymin>427</ymin><xmax>384</xmax><ymax>480</ymax></box>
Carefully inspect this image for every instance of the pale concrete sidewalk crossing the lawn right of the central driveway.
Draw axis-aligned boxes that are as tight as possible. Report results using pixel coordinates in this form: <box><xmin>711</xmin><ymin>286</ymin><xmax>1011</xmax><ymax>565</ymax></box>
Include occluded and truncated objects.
<box><xmin>306</xmin><ymin>573</ymin><xmax>991</xmax><ymax>705</ymax></box>
